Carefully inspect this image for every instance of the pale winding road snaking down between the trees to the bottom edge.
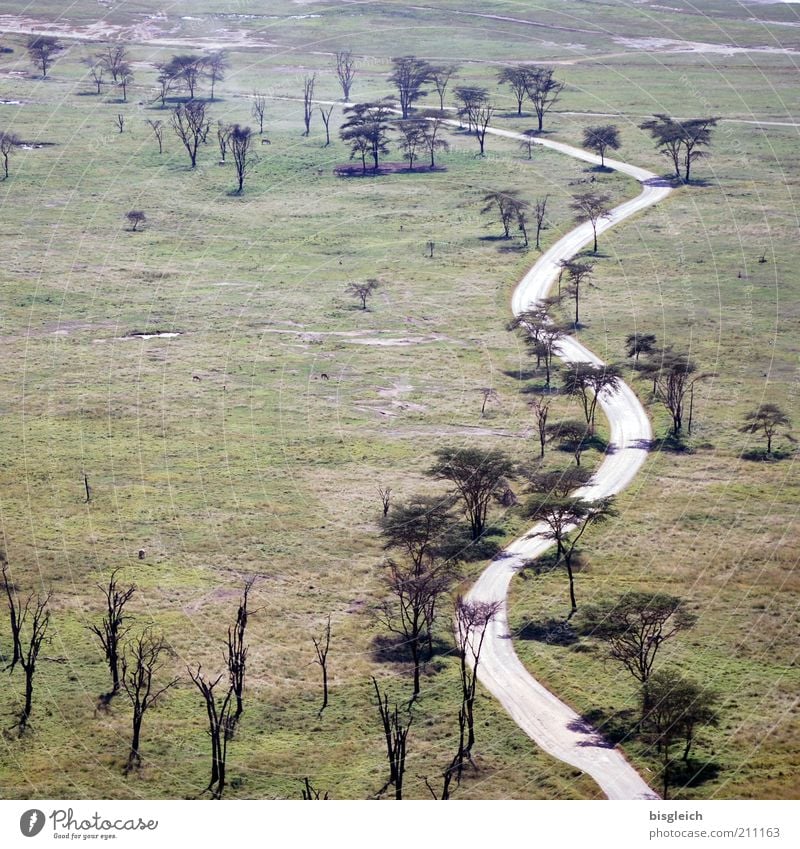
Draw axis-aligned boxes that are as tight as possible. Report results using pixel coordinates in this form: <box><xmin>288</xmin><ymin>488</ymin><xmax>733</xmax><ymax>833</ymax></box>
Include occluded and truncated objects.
<box><xmin>467</xmin><ymin>124</ymin><xmax>671</xmax><ymax>799</ymax></box>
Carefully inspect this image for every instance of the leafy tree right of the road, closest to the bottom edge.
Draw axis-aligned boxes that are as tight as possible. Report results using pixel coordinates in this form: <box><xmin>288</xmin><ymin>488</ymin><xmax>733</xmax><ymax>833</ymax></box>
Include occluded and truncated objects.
<box><xmin>644</xmin><ymin>670</ymin><xmax>719</xmax><ymax>799</ymax></box>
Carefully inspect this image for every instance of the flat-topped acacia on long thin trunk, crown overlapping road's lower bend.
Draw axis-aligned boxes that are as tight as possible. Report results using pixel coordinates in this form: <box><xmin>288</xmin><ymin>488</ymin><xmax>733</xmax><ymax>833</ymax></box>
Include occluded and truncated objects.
<box><xmin>526</xmin><ymin>493</ymin><xmax>616</xmax><ymax>620</ymax></box>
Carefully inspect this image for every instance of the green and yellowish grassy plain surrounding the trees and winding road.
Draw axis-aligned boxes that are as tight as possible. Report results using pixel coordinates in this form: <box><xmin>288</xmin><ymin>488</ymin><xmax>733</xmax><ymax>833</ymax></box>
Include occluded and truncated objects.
<box><xmin>0</xmin><ymin>2</ymin><xmax>800</xmax><ymax>798</ymax></box>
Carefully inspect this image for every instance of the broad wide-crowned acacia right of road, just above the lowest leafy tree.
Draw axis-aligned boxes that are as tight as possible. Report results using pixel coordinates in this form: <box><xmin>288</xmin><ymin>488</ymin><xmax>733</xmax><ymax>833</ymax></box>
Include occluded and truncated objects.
<box><xmin>583</xmin><ymin>592</ymin><xmax>697</xmax><ymax>716</ymax></box>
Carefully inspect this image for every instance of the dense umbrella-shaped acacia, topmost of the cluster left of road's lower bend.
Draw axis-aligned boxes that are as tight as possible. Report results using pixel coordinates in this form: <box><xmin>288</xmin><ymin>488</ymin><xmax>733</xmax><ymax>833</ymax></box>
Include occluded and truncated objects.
<box><xmin>427</xmin><ymin>448</ymin><xmax>515</xmax><ymax>540</ymax></box>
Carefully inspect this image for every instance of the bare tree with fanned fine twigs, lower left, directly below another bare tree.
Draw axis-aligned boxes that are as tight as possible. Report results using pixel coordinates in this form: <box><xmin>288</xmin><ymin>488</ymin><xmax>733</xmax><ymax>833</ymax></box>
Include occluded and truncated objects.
<box><xmin>121</xmin><ymin>628</ymin><xmax>179</xmax><ymax>773</ymax></box>
